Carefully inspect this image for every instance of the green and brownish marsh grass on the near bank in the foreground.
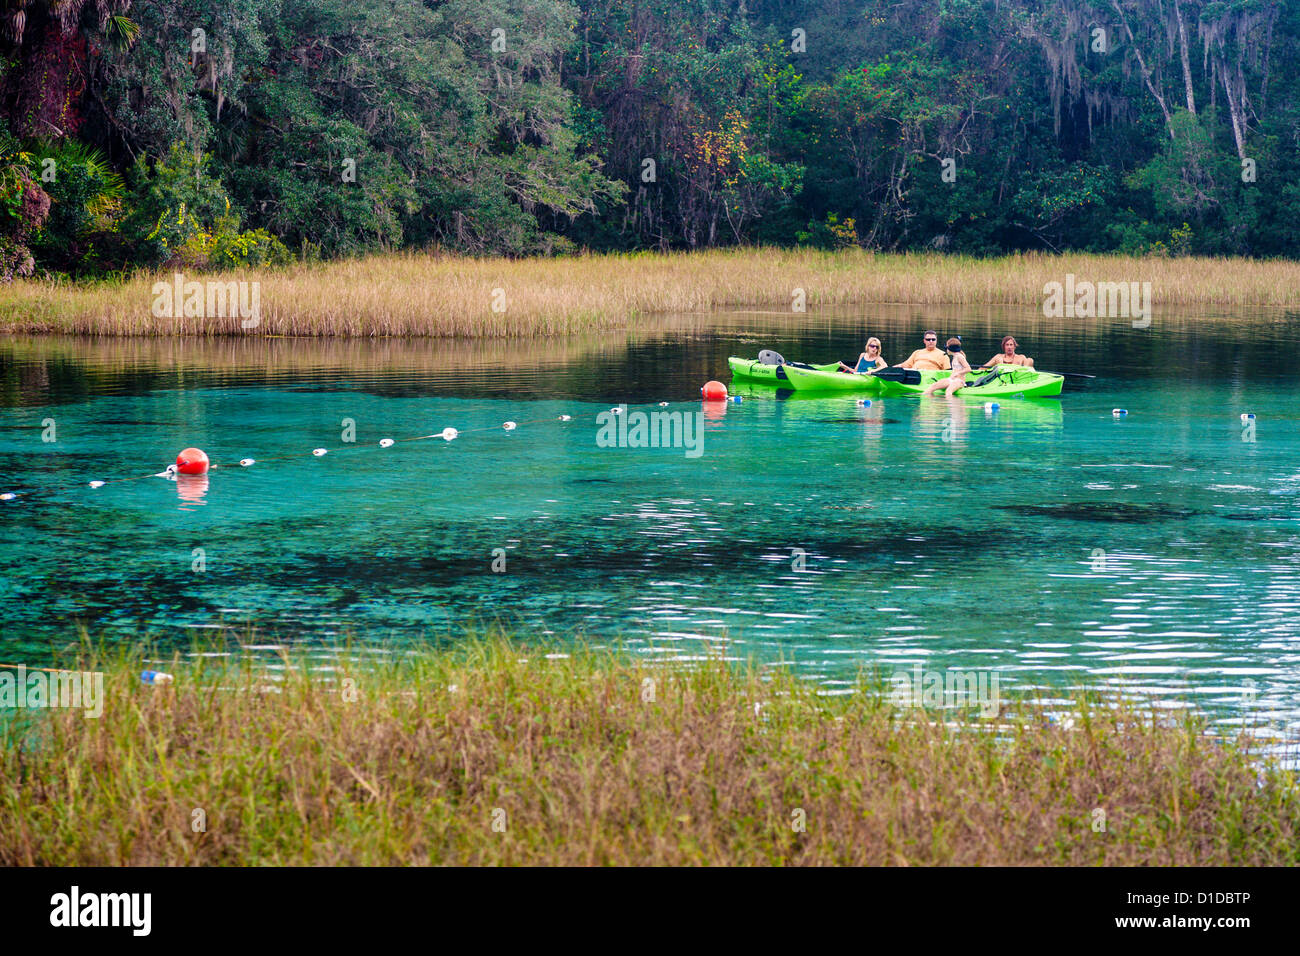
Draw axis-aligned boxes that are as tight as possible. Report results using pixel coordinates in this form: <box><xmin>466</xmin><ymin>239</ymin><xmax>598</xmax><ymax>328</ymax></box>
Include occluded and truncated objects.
<box><xmin>0</xmin><ymin>639</ymin><xmax>1300</xmax><ymax>865</ymax></box>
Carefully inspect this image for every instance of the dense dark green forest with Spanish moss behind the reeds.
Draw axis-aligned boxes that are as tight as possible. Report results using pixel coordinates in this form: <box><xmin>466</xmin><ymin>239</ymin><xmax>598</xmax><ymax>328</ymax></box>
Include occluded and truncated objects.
<box><xmin>0</xmin><ymin>0</ymin><xmax>1300</xmax><ymax>278</ymax></box>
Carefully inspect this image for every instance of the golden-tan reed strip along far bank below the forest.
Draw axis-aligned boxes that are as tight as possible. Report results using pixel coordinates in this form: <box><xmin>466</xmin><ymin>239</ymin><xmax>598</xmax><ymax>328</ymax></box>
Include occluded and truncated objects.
<box><xmin>0</xmin><ymin>248</ymin><xmax>1300</xmax><ymax>337</ymax></box>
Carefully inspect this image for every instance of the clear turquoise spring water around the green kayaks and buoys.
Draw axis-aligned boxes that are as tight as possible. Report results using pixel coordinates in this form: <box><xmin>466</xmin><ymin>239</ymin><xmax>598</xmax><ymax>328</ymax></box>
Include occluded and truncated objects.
<box><xmin>0</xmin><ymin>306</ymin><xmax>1300</xmax><ymax>730</ymax></box>
